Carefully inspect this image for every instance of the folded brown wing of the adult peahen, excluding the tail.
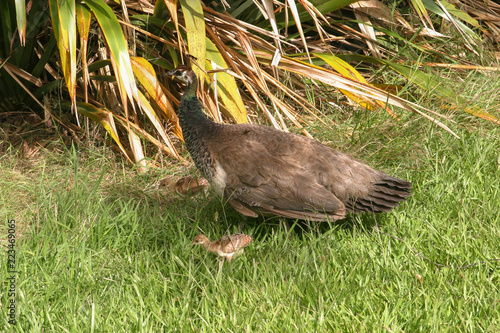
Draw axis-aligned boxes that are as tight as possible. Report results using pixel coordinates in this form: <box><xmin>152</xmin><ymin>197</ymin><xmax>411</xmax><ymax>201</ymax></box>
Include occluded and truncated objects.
<box><xmin>212</xmin><ymin>127</ymin><xmax>345</xmax><ymax>218</ymax></box>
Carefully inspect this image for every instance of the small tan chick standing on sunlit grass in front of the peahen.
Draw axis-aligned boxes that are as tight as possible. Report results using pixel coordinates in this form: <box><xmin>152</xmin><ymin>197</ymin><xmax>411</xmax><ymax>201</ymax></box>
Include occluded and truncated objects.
<box><xmin>191</xmin><ymin>234</ymin><xmax>253</xmax><ymax>261</ymax></box>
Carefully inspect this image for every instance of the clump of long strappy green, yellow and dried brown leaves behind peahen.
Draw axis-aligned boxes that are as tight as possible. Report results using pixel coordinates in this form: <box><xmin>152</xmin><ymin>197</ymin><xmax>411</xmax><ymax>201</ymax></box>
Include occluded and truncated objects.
<box><xmin>0</xmin><ymin>0</ymin><xmax>499</xmax><ymax>167</ymax></box>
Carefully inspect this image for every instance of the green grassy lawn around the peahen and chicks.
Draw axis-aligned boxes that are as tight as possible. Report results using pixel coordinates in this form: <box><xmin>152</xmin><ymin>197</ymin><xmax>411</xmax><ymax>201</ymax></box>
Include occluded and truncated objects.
<box><xmin>0</xmin><ymin>100</ymin><xmax>500</xmax><ymax>332</ymax></box>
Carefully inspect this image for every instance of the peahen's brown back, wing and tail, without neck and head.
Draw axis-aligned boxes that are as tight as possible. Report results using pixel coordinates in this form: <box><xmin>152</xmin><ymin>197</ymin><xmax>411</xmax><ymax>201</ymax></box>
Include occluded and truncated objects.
<box><xmin>212</xmin><ymin>125</ymin><xmax>411</xmax><ymax>221</ymax></box>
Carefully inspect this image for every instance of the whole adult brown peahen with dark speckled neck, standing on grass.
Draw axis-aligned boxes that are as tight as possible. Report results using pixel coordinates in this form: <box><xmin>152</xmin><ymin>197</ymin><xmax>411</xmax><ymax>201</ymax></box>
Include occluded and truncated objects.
<box><xmin>168</xmin><ymin>65</ymin><xmax>411</xmax><ymax>221</ymax></box>
